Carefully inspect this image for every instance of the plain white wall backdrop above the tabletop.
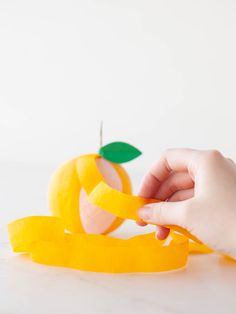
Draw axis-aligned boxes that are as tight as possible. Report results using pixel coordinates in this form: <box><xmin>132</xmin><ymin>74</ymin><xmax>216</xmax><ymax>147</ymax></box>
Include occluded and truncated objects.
<box><xmin>0</xmin><ymin>0</ymin><xmax>236</xmax><ymax>169</ymax></box>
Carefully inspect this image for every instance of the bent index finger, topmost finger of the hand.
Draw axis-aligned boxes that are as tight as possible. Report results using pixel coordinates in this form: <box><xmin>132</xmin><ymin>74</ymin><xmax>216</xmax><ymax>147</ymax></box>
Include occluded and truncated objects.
<box><xmin>139</xmin><ymin>149</ymin><xmax>198</xmax><ymax>197</ymax></box>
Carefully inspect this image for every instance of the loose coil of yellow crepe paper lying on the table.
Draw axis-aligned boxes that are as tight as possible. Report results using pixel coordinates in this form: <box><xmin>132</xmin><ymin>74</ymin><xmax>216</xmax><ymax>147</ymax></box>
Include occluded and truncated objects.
<box><xmin>9</xmin><ymin>216</ymin><xmax>188</xmax><ymax>273</ymax></box>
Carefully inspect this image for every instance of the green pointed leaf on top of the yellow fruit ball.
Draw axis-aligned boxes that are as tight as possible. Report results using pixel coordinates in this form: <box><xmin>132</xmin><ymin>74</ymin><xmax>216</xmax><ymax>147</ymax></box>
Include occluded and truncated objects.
<box><xmin>99</xmin><ymin>142</ymin><xmax>142</xmax><ymax>164</ymax></box>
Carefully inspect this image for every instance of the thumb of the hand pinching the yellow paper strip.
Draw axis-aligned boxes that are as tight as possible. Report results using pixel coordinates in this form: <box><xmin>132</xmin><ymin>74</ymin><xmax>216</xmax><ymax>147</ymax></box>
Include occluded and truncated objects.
<box><xmin>138</xmin><ymin>200</ymin><xmax>188</xmax><ymax>226</ymax></box>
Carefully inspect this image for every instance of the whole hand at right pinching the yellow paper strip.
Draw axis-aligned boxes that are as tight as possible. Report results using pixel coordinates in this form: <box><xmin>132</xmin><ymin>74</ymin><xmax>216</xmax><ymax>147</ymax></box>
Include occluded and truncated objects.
<box><xmin>139</xmin><ymin>149</ymin><xmax>236</xmax><ymax>258</ymax></box>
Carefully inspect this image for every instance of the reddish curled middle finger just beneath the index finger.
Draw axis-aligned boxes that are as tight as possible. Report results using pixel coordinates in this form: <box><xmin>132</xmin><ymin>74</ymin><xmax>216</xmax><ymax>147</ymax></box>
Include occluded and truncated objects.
<box><xmin>155</xmin><ymin>172</ymin><xmax>194</xmax><ymax>201</ymax></box>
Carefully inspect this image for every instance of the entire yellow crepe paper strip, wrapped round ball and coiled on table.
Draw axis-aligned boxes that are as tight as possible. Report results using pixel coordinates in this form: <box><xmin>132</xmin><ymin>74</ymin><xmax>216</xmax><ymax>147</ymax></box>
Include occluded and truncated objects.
<box><xmin>8</xmin><ymin>155</ymin><xmax>211</xmax><ymax>273</ymax></box>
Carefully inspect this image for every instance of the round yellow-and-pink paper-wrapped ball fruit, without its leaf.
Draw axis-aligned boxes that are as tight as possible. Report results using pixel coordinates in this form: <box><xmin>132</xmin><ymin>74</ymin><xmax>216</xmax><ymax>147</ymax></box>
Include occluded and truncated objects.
<box><xmin>48</xmin><ymin>154</ymin><xmax>131</xmax><ymax>234</ymax></box>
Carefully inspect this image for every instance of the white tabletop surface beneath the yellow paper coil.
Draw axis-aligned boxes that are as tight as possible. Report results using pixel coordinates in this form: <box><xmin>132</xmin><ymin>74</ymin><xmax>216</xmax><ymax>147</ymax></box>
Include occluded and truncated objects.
<box><xmin>0</xmin><ymin>164</ymin><xmax>236</xmax><ymax>314</ymax></box>
